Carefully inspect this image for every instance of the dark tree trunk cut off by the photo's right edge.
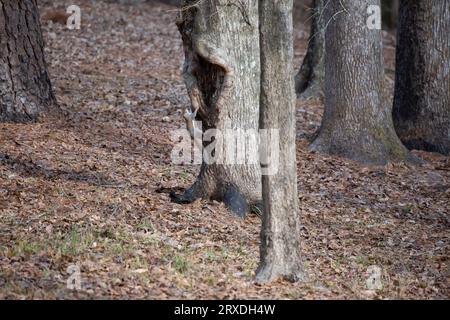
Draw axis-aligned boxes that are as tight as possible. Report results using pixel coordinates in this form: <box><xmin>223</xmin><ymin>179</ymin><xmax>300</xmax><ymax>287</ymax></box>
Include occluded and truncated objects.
<box><xmin>393</xmin><ymin>0</ymin><xmax>450</xmax><ymax>155</ymax></box>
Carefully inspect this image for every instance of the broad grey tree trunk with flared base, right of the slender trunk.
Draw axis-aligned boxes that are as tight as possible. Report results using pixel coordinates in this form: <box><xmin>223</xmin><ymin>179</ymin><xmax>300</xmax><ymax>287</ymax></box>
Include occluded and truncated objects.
<box><xmin>311</xmin><ymin>0</ymin><xmax>411</xmax><ymax>164</ymax></box>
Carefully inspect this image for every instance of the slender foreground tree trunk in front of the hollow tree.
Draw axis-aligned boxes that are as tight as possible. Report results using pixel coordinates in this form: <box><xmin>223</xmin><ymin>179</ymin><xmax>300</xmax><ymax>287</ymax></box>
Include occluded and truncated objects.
<box><xmin>256</xmin><ymin>0</ymin><xmax>304</xmax><ymax>282</ymax></box>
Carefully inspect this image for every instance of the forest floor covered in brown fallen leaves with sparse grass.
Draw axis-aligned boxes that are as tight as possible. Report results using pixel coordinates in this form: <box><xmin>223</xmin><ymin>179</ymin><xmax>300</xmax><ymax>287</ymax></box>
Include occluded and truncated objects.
<box><xmin>0</xmin><ymin>0</ymin><xmax>450</xmax><ymax>299</ymax></box>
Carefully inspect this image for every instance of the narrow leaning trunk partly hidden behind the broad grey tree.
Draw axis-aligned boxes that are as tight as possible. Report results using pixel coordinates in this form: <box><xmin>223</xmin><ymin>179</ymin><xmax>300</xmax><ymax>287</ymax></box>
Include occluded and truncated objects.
<box><xmin>295</xmin><ymin>0</ymin><xmax>326</xmax><ymax>99</ymax></box>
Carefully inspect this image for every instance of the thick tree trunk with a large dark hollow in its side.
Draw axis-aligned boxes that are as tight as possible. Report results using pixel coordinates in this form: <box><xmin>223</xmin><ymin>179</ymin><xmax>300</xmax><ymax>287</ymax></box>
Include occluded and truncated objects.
<box><xmin>172</xmin><ymin>0</ymin><xmax>261</xmax><ymax>217</ymax></box>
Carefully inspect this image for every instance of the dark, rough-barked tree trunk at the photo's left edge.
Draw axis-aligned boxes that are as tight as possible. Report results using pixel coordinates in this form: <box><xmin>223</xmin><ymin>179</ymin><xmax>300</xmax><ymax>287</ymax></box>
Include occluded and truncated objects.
<box><xmin>0</xmin><ymin>0</ymin><xmax>55</xmax><ymax>122</ymax></box>
